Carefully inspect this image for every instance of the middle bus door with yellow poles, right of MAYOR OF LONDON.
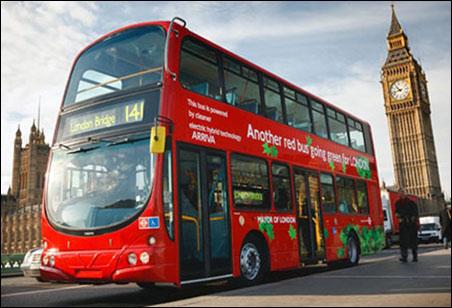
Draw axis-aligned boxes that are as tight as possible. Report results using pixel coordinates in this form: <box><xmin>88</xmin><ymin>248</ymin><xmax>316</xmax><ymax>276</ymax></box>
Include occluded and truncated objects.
<box><xmin>294</xmin><ymin>168</ymin><xmax>325</xmax><ymax>262</ymax></box>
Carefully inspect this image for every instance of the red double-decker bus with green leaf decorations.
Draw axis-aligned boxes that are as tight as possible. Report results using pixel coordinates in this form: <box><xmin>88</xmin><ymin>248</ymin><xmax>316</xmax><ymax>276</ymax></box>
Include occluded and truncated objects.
<box><xmin>41</xmin><ymin>18</ymin><xmax>384</xmax><ymax>287</ymax></box>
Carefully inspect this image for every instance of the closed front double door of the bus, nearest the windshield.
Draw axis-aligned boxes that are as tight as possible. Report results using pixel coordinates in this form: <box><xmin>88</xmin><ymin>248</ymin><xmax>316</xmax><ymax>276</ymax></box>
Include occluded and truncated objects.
<box><xmin>178</xmin><ymin>146</ymin><xmax>232</xmax><ymax>283</ymax></box>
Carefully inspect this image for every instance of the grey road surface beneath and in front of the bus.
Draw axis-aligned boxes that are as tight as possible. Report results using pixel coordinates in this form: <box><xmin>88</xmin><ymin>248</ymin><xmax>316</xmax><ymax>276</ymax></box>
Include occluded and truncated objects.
<box><xmin>1</xmin><ymin>245</ymin><xmax>451</xmax><ymax>307</ymax></box>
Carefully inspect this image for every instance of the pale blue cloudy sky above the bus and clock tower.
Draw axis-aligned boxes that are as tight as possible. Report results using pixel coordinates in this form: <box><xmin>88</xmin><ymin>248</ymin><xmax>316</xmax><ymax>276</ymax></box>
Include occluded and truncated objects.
<box><xmin>1</xmin><ymin>1</ymin><xmax>451</xmax><ymax>197</ymax></box>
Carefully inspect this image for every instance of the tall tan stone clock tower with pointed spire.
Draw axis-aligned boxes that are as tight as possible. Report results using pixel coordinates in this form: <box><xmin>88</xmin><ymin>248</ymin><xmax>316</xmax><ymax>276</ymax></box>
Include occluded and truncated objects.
<box><xmin>381</xmin><ymin>5</ymin><xmax>444</xmax><ymax>214</ymax></box>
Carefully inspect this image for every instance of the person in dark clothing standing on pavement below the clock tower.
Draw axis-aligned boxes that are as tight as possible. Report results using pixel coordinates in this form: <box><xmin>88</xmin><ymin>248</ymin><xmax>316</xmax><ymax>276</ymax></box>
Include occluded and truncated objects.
<box><xmin>395</xmin><ymin>189</ymin><xmax>419</xmax><ymax>263</ymax></box>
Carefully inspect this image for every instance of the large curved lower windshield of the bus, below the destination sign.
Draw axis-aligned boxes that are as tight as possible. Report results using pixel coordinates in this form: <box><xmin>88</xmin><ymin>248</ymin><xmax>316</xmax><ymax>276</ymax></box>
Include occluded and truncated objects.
<box><xmin>46</xmin><ymin>135</ymin><xmax>155</xmax><ymax>230</ymax></box>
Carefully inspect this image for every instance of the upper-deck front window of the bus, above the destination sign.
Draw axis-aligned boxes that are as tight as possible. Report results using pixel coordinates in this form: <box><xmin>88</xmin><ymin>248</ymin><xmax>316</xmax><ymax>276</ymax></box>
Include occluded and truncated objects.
<box><xmin>64</xmin><ymin>26</ymin><xmax>165</xmax><ymax>106</ymax></box>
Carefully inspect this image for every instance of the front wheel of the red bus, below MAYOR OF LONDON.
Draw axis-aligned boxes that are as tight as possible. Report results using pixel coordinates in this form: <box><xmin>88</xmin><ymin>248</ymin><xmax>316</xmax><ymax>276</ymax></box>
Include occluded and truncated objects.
<box><xmin>239</xmin><ymin>235</ymin><xmax>269</xmax><ymax>285</ymax></box>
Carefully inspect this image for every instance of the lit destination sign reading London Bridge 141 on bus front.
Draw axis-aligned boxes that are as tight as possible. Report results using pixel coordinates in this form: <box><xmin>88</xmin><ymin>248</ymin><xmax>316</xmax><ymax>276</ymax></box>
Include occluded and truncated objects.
<box><xmin>63</xmin><ymin>99</ymin><xmax>144</xmax><ymax>137</ymax></box>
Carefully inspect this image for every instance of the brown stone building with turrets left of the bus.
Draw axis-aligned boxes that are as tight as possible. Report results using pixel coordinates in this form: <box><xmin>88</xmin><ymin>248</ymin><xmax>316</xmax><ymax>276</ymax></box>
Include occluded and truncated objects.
<box><xmin>1</xmin><ymin>123</ymin><xmax>50</xmax><ymax>254</ymax></box>
